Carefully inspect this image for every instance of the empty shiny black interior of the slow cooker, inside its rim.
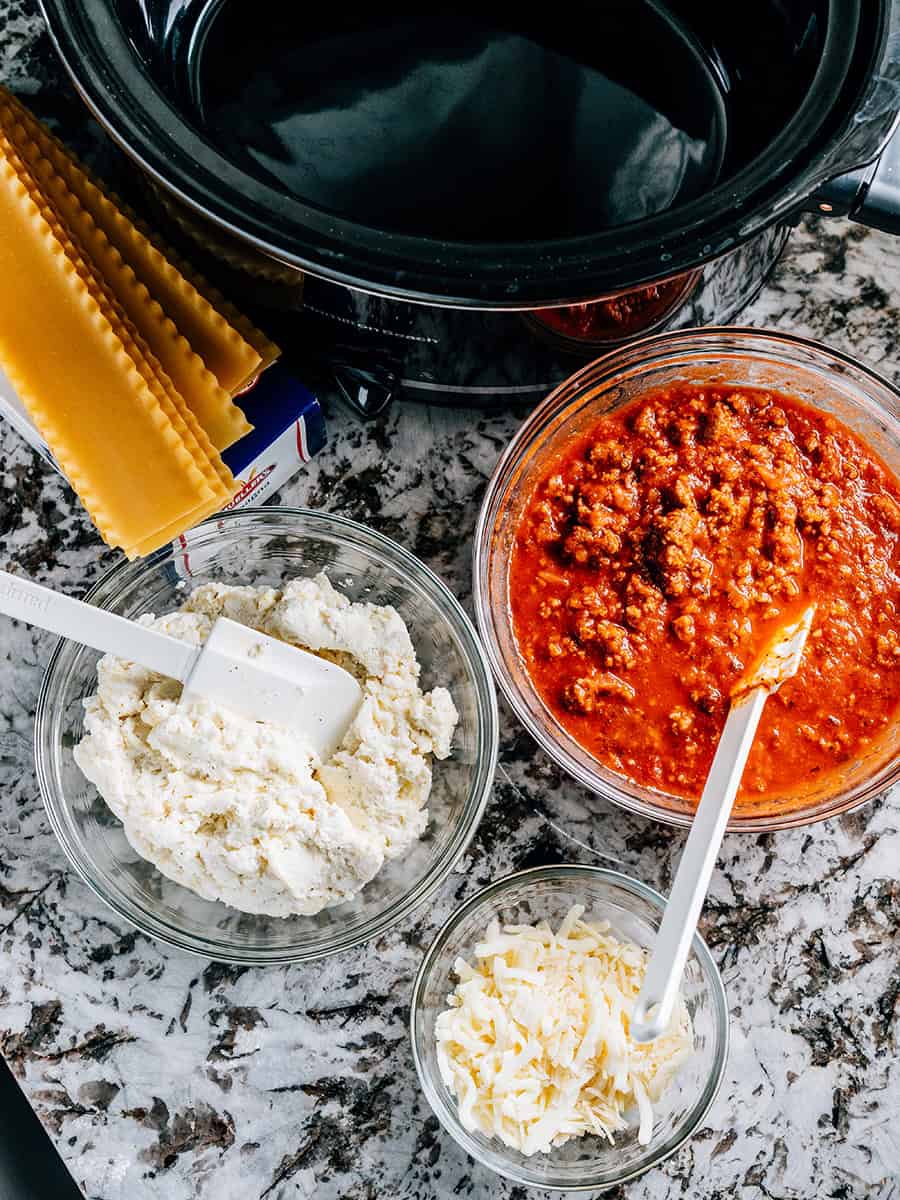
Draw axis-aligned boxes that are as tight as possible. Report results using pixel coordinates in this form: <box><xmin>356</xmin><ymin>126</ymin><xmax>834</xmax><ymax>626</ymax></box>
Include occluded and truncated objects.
<box><xmin>139</xmin><ymin>0</ymin><xmax>828</xmax><ymax>242</ymax></box>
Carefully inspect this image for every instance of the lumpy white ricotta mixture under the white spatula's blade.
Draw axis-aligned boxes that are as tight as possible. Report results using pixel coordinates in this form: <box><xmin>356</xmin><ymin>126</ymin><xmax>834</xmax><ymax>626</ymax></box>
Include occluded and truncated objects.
<box><xmin>74</xmin><ymin>575</ymin><xmax>458</xmax><ymax>917</ymax></box>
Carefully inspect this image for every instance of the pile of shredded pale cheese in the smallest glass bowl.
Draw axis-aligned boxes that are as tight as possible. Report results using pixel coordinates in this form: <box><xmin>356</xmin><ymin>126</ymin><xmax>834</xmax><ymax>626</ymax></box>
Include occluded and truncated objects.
<box><xmin>436</xmin><ymin>905</ymin><xmax>694</xmax><ymax>1154</ymax></box>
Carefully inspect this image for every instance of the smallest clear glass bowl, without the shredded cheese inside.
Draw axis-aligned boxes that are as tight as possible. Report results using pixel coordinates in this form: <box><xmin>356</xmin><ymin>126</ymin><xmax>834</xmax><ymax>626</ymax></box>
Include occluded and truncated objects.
<box><xmin>409</xmin><ymin>865</ymin><xmax>728</xmax><ymax>1192</ymax></box>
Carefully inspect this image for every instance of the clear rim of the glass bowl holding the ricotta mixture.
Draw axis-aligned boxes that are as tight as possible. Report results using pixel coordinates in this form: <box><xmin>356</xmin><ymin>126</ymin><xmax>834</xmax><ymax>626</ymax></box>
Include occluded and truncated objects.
<box><xmin>32</xmin><ymin>505</ymin><xmax>499</xmax><ymax>966</ymax></box>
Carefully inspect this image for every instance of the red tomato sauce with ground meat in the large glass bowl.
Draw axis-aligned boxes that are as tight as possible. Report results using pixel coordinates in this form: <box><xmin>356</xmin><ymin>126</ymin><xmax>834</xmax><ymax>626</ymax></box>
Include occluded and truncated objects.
<box><xmin>510</xmin><ymin>384</ymin><xmax>900</xmax><ymax>808</ymax></box>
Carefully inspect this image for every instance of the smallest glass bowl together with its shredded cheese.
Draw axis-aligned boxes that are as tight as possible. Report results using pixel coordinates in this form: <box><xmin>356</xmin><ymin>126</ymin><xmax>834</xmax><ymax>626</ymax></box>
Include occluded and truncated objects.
<box><xmin>410</xmin><ymin>865</ymin><xmax>728</xmax><ymax>1192</ymax></box>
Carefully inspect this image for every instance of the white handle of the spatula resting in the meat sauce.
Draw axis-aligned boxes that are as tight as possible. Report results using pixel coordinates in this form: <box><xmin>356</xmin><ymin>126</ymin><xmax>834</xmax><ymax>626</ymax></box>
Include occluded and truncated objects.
<box><xmin>629</xmin><ymin>688</ymin><xmax>768</xmax><ymax>1042</ymax></box>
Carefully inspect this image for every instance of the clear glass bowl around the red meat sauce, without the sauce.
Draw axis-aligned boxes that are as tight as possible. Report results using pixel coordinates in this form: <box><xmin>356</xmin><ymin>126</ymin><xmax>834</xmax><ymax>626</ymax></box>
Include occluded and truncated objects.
<box><xmin>474</xmin><ymin>328</ymin><xmax>900</xmax><ymax>832</ymax></box>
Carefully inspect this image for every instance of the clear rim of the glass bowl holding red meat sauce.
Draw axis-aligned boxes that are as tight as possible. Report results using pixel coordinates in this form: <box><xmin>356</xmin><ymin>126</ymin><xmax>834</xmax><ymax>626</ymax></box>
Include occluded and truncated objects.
<box><xmin>472</xmin><ymin>325</ymin><xmax>900</xmax><ymax>834</ymax></box>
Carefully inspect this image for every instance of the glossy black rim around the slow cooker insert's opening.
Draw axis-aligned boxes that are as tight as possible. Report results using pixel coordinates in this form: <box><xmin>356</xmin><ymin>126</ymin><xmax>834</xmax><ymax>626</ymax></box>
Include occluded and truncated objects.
<box><xmin>38</xmin><ymin>0</ymin><xmax>890</xmax><ymax>310</ymax></box>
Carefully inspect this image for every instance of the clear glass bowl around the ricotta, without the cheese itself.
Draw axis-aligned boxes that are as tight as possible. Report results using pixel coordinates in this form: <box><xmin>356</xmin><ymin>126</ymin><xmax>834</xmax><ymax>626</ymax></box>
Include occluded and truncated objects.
<box><xmin>35</xmin><ymin>508</ymin><xmax>498</xmax><ymax>964</ymax></box>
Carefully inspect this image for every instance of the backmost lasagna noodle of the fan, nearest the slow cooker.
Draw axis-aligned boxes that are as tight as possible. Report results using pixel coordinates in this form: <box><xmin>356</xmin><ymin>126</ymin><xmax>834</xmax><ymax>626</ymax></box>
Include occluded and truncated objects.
<box><xmin>0</xmin><ymin>89</ymin><xmax>278</xmax><ymax>394</ymax></box>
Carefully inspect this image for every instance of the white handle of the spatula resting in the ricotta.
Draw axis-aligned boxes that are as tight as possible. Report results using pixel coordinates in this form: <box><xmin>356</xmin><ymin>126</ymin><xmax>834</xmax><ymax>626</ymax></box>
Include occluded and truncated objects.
<box><xmin>0</xmin><ymin>571</ymin><xmax>199</xmax><ymax>683</ymax></box>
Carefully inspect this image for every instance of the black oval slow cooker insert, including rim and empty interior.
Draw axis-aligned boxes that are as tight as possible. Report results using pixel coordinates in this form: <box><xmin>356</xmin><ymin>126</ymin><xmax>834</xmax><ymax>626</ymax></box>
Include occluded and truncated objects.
<box><xmin>40</xmin><ymin>0</ymin><xmax>900</xmax><ymax>308</ymax></box>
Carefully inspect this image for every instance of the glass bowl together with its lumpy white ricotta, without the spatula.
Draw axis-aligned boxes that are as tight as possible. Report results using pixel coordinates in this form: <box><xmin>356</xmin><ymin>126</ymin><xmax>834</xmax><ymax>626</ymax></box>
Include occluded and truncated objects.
<box><xmin>35</xmin><ymin>508</ymin><xmax>498</xmax><ymax>964</ymax></box>
